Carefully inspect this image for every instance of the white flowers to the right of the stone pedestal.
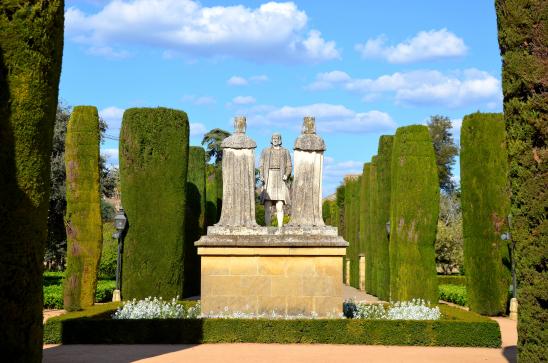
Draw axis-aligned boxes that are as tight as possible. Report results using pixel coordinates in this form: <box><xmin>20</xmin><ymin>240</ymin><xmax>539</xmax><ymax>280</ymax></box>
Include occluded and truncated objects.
<box><xmin>344</xmin><ymin>299</ymin><xmax>441</xmax><ymax>320</ymax></box>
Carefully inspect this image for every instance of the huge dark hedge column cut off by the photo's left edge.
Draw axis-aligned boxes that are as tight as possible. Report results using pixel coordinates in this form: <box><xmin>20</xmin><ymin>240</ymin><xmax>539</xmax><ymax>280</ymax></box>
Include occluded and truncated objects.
<box><xmin>0</xmin><ymin>0</ymin><xmax>64</xmax><ymax>362</ymax></box>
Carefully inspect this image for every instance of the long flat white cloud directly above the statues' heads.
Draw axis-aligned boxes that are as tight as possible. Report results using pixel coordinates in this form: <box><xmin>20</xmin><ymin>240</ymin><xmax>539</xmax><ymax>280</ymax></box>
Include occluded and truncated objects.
<box><xmin>243</xmin><ymin>103</ymin><xmax>397</xmax><ymax>133</ymax></box>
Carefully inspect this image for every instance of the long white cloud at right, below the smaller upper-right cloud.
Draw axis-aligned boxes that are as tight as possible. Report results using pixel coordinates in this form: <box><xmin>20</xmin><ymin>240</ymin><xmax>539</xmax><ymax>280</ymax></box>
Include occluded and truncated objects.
<box><xmin>307</xmin><ymin>68</ymin><xmax>502</xmax><ymax>108</ymax></box>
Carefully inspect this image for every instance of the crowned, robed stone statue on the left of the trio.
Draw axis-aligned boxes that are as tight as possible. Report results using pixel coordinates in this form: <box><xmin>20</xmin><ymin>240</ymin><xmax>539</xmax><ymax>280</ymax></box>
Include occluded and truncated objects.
<box><xmin>217</xmin><ymin>117</ymin><xmax>257</xmax><ymax>227</ymax></box>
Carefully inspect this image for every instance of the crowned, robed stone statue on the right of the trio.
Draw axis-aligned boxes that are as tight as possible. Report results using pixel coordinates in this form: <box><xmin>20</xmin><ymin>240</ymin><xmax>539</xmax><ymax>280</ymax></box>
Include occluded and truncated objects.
<box><xmin>289</xmin><ymin>117</ymin><xmax>325</xmax><ymax>226</ymax></box>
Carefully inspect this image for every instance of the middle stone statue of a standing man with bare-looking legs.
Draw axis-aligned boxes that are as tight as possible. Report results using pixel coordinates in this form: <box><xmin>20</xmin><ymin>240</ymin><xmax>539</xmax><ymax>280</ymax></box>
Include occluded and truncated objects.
<box><xmin>259</xmin><ymin>133</ymin><xmax>291</xmax><ymax>227</ymax></box>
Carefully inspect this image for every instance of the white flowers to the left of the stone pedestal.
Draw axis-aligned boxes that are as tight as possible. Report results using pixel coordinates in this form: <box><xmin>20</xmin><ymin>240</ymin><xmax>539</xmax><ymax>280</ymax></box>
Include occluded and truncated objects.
<box><xmin>112</xmin><ymin>296</ymin><xmax>200</xmax><ymax>319</ymax></box>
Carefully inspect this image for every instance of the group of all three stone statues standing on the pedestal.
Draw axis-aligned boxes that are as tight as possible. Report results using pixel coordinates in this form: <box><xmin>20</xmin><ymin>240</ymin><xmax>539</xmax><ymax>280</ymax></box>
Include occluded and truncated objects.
<box><xmin>218</xmin><ymin>117</ymin><xmax>325</xmax><ymax>227</ymax></box>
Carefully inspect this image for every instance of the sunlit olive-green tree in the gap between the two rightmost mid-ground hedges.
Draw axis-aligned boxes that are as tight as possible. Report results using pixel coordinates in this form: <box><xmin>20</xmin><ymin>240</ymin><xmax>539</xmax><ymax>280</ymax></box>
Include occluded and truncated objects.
<box><xmin>435</xmin><ymin>192</ymin><xmax>463</xmax><ymax>274</ymax></box>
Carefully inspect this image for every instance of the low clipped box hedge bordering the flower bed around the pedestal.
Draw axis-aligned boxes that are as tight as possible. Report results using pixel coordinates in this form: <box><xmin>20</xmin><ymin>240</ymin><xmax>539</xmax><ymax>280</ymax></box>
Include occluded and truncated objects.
<box><xmin>44</xmin><ymin>303</ymin><xmax>501</xmax><ymax>347</ymax></box>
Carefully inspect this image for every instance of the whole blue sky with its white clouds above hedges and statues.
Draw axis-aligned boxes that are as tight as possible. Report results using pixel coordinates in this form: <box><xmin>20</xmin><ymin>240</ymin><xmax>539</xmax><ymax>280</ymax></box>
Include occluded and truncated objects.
<box><xmin>60</xmin><ymin>0</ymin><xmax>502</xmax><ymax>195</ymax></box>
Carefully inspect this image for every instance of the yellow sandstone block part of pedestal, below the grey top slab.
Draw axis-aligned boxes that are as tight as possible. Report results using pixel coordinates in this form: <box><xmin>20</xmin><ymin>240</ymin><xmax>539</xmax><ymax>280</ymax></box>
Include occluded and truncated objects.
<box><xmin>198</xmin><ymin>247</ymin><xmax>346</xmax><ymax>317</ymax></box>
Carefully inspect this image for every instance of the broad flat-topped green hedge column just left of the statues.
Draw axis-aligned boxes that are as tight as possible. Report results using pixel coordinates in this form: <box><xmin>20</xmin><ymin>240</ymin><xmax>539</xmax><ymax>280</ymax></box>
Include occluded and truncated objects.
<box><xmin>120</xmin><ymin>108</ymin><xmax>188</xmax><ymax>299</ymax></box>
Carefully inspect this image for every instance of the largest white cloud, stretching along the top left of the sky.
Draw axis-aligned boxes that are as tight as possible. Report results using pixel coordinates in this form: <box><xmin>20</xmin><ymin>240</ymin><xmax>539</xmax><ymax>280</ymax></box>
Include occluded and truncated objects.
<box><xmin>65</xmin><ymin>0</ymin><xmax>340</xmax><ymax>62</ymax></box>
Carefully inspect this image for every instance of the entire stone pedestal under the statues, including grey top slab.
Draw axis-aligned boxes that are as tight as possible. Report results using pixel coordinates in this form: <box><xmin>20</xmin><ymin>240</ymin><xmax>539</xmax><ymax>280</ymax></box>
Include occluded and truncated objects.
<box><xmin>196</xmin><ymin>226</ymin><xmax>348</xmax><ymax>317</ymax></box>
